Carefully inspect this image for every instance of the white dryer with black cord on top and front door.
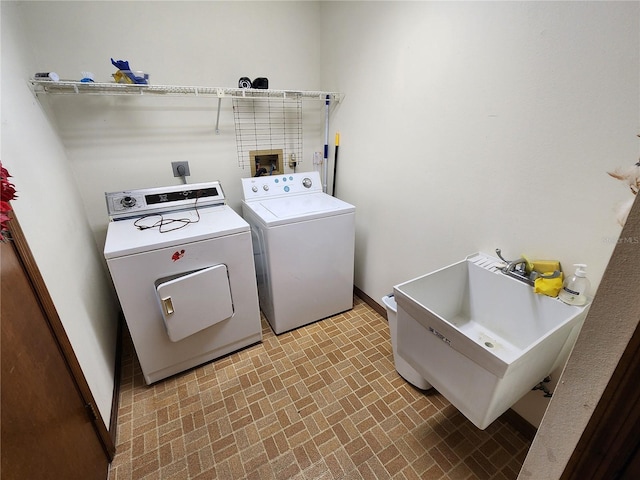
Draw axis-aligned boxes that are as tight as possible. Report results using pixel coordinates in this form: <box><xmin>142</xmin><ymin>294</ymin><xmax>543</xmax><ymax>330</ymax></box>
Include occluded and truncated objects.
<box><xmin>104</xmin><ymin>182</ymin><xmax>262</xmax><ymax>384</ymax></box>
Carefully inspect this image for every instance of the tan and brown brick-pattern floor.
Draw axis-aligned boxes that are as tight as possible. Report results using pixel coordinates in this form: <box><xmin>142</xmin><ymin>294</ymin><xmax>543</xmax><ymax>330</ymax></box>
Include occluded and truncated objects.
<box><xmin>109</xmin><ymin>297</ymin><xmax>530</xmax><ymax>480</ymax></box>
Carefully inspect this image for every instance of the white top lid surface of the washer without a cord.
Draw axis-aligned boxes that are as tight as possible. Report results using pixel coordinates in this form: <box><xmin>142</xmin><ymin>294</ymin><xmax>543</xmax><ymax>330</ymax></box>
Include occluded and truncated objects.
<box><xmin>243</xmin><ymin>192</ymin><xmax>356</xmax><ymax>226</ymax></box>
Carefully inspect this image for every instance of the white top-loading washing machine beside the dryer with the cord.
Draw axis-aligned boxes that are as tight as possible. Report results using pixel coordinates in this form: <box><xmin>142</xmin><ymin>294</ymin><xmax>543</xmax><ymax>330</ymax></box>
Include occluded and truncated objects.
<box><xmin>242</xmin><ymin>172</ymin><xmax>355</xmax><ymax>334</ymax></box>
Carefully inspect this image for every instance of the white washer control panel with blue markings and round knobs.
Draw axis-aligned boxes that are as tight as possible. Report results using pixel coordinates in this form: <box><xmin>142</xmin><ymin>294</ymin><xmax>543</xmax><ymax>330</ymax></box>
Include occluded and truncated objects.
<box><xmin>242</xmin><ymin>172</ymin><xmax>322</xmax><ymax>202</ymax></box>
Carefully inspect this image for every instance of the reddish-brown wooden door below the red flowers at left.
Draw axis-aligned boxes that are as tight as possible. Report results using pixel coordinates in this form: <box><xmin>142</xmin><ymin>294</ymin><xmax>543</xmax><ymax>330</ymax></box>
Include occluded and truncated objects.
<box><xmin>0</xmin><ymin>223</ymin><xmax>109</xmax><ymax>480</ymax></box>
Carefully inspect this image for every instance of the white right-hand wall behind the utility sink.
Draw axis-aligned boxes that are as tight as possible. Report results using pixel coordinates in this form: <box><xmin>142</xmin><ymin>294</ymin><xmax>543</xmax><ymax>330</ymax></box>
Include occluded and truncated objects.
<box><xmin>321</xmin><ymin>2</ymin><xmax>640</xmax><ymax>425</ymax></box>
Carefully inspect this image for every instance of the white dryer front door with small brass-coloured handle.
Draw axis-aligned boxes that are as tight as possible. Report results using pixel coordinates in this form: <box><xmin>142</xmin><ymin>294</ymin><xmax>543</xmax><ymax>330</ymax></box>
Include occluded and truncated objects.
<box><xmin>156</xmin><ymin>264</ymin><xmax>233</xmax><ymax>342</ymax></box>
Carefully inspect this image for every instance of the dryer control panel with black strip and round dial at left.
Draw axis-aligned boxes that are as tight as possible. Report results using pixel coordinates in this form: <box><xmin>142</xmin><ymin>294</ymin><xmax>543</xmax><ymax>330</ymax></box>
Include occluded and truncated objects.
<box><xmin>109</xmin><ymin>182</ymin><xmax>225</xmax><ymax>220</ymax></box>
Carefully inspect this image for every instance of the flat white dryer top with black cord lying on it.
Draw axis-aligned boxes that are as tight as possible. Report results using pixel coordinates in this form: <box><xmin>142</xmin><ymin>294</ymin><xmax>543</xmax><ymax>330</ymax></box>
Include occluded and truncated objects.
<box><xmin>104</xmin><ymin>205</ymin><xmax>249</xmax><ymax>259</ymax></box>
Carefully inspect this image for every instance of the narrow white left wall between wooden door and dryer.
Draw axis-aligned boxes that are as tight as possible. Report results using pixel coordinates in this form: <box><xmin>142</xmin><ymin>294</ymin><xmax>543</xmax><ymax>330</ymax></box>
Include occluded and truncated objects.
<box><xmin>1</xmin><ymin>2</ymin><xmax>117</xmax><ymax>425</ymax></box>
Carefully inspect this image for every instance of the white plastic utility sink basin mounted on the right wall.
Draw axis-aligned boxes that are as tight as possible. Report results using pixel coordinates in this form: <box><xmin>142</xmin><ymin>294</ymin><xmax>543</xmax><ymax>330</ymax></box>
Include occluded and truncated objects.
<box><xmin>393</xmin><ymin>253</ymin><xmax>587</xmax><ymax>429</ymax></box>
